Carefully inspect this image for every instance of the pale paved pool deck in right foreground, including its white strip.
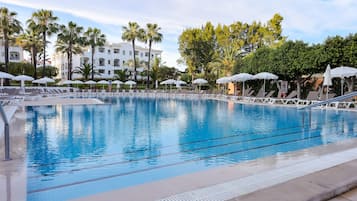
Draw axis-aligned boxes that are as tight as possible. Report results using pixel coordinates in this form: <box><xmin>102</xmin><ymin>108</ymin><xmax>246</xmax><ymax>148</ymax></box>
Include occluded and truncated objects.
<box><xmin>70</xmin><ymin>140</ymin><xmax>357</xmax><ymax>201</ymax></box>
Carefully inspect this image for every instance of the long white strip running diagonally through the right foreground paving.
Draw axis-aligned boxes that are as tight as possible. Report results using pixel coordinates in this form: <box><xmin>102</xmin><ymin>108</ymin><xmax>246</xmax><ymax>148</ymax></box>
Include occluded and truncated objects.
<box><xmin>160</xmin><ymin>148</ymin><xmax>357</xmax><ymax>201</ymax></box>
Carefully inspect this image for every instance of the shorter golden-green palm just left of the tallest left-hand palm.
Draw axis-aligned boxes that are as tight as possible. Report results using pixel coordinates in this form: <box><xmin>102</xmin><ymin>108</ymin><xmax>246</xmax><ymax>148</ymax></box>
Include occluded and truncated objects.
<box><xmin>16</xmin><ymin>27</ymin><xmax>42</xmax><ymax>79</ymax></box>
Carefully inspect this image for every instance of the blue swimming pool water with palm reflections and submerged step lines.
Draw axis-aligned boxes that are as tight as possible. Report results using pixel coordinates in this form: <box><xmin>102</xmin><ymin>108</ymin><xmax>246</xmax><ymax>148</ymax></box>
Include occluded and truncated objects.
<box><xmin>26</xmin><ymin>98</ymin><xmax>357</xmax><ymax>201</ymax></box>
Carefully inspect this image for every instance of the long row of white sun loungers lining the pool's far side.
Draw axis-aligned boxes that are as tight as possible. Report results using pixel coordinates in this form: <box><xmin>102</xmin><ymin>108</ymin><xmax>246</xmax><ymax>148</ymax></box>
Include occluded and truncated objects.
<box><xmin>2</xmin><ymin>87</ymin><xmax>356</xmax><ymax>108</ymax></box>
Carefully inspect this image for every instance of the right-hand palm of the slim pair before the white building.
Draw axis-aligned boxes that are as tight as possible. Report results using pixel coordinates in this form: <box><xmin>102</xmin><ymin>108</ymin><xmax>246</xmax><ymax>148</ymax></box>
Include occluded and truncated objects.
<box><xmin>145</xmin><ymin>23</ymin><xmax>162</xmax><ymax>88</ymax></box>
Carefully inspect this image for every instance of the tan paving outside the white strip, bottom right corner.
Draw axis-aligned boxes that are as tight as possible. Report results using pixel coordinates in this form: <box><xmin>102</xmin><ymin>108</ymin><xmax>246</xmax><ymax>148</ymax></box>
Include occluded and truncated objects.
<box><xmin>229</xmin><ymin>160</ymin><xmax>357</xmax><ymax>201</ymax></box>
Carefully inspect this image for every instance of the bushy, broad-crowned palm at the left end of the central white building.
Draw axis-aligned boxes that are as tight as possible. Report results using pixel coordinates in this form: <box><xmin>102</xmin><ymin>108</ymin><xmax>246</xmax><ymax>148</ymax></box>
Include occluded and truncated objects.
<box><xmin>56</xmin><ymin>21</ymin><xmax>83</xmax><ymax>80</ymax></box>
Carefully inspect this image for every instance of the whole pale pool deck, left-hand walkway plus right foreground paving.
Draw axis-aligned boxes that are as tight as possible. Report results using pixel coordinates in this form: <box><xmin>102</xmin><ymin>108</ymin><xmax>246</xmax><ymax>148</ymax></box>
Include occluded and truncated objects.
<box><xmin>0</xmin><ymin>94</ymin><xmax>357</xmax><ymax>201</ymax></box>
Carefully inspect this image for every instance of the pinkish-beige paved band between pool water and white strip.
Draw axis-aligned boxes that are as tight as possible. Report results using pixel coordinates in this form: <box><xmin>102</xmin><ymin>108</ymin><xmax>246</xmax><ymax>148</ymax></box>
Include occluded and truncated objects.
<box><xmin>70</xmin><ymin>139</ymin><xmax>357</xmax><ymax>201</ymax></box>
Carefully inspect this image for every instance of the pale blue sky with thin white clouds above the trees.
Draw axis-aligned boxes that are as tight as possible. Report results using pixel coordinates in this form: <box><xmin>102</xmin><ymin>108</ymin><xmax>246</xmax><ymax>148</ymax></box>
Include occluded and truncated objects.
<box><xmin>0</xmin><ymin>0</ymin><xmax>357</xmax><ymax>69</ymax></box>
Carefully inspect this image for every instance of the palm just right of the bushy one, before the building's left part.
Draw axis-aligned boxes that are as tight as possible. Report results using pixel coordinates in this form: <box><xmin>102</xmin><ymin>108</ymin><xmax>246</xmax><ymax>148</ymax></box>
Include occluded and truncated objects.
<box><xmin>84</xmin><ymin>27</ymin><xmax>106</xmax><ymax>80</ymax></box>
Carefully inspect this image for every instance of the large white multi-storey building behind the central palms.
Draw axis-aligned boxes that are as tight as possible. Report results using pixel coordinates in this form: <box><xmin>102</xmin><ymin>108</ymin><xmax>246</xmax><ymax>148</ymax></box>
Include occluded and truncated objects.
<box><xmin>52</xmin><ymin>43</ymin><xmax>162</xmax><ymax>80</ymax></box>
